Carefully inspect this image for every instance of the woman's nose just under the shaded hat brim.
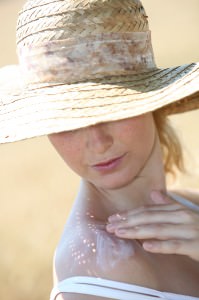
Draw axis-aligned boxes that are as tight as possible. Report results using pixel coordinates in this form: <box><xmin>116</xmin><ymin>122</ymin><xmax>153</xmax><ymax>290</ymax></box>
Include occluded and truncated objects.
<box><xmin>86</xmin><ymin>124</ymin><xmax>113</xmax><ymax>153</ymax></box>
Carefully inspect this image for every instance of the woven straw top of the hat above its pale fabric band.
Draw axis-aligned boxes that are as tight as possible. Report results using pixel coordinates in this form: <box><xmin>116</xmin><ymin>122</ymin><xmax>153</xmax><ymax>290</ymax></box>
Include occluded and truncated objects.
<box><xmin>17</xmin><ymin>0</ymin><xmax>149</xmax><ymax>46</ymax></box>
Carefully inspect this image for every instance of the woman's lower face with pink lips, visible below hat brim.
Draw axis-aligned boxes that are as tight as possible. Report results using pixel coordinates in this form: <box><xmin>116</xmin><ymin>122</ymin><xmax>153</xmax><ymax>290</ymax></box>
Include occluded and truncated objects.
<box><xmin>49</xmin><ymin>113</ymin><xmax>155</xmax><ymax>189</ymax></box>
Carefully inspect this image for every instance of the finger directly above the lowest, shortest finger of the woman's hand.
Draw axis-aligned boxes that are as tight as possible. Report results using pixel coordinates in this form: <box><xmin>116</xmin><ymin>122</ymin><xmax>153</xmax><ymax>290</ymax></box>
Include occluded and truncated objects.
<box><xmin>115</xmin><ymin>224</ymin><xmax>199</xmax><ymax>240</ymax></box>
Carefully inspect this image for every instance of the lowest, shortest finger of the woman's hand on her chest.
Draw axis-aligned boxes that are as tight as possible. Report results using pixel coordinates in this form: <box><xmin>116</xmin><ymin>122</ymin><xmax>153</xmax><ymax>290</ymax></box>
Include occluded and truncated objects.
<box><xmin>142</xmin><ymin>239</ymin><xmax>199</xmax><ymax>261</ymax></box>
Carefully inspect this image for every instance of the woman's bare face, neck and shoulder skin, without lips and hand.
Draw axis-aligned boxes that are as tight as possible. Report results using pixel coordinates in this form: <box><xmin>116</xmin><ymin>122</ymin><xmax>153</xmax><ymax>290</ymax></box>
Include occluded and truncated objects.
<box><xmin>49</xmin><ymin>113</ymin><xmax>198</xmax><ymax>299</ymax></box>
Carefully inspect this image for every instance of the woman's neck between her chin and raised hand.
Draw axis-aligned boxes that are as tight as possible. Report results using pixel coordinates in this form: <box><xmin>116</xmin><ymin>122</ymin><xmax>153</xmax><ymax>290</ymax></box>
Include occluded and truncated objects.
<box><xmin>71</xmin><ymin>134</ymin><xmax>166</xmax><ymax>222</ymax></box>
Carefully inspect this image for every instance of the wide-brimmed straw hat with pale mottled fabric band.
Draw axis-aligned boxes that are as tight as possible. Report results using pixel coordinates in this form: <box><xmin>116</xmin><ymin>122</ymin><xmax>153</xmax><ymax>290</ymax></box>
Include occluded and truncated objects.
<box><xmin>0</xmin><ymin>0</ymin><xmax>199</xmax><ymax>143</ymax></box>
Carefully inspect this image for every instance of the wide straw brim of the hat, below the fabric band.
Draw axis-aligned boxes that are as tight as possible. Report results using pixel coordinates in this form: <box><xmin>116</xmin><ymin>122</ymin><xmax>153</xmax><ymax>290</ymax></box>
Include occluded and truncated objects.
<box><xmin>0</xmin><ymin>63</ymin><xmax>199</xmax><ymax>143</ymax></box>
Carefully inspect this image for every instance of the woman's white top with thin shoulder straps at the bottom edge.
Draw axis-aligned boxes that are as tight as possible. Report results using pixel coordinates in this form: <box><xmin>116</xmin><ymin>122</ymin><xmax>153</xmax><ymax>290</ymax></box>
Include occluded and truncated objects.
<box><xmin>50</xmin><ymin>193</ymin><xmax>199</xmax><ymax>300</ymax></box>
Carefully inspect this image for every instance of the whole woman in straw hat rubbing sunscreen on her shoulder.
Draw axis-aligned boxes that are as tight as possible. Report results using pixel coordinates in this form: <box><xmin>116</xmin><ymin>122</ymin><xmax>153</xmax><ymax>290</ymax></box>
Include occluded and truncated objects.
<box><xmin>0</xmin><ymin>0</ymin><xmax>199</xmax><ymax>300</ymax></box>
